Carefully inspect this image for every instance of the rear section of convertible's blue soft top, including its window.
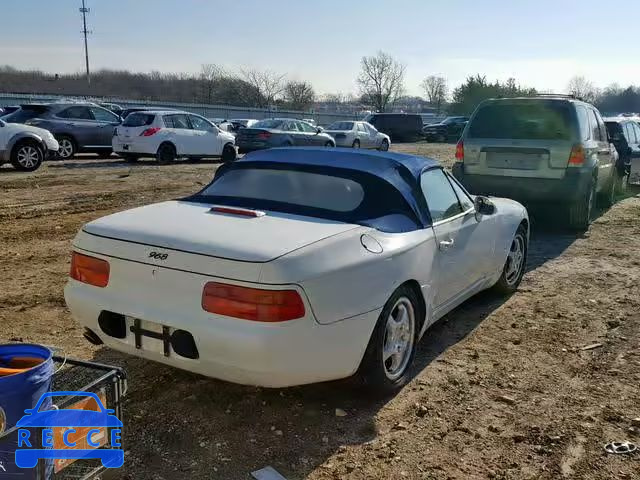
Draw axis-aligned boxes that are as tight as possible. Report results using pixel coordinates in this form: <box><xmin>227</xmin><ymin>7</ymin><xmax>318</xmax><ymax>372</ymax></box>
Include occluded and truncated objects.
<box><xmin>185</xmin><ymin>162</ymin><xmax>418</xmax><ymax>232</ymax></box>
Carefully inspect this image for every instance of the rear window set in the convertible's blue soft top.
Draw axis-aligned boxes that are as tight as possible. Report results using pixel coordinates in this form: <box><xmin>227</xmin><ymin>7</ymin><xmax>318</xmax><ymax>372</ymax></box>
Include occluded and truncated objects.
<box><xmin>203</xmin><ymin>169</ymin><xmax>364</xmax><ymax>212</ymax></box>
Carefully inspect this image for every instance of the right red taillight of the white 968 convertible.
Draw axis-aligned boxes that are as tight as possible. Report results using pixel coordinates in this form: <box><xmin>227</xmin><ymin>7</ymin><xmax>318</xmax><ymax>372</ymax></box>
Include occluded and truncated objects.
<box><xmin>202</xmin><ymin>282</ymin><xmax>305</xmax><ymax>322</ymax></box>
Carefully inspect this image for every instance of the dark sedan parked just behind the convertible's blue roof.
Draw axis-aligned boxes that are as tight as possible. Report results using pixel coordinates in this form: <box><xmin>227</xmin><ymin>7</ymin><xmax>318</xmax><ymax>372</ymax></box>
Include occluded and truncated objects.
<box><xmin>236</xmin><ymin>118</ymin><xmax>336</xmax><ymax>153</ymax></box>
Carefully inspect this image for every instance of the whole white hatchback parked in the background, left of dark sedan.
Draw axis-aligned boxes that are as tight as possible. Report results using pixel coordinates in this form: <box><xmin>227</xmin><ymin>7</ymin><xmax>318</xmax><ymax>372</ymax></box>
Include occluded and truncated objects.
<box><xmin>112</xmin><ymin>110</ymin><xmax>236</xmax><ymax>164</ymax></box>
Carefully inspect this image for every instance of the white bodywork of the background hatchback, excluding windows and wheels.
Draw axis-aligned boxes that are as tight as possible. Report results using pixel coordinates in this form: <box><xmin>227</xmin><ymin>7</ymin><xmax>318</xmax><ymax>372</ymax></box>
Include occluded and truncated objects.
<box><xmin>112</xmin><ymin>111</ymin><xmax>235</xmax><ymax>157</ymax></box>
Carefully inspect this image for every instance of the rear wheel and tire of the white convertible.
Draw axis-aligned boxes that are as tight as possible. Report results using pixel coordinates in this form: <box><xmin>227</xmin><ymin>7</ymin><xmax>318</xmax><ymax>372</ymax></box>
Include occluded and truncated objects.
<box><xmin>356</xmin><ymin>285</ymin><xmax>424</xmax><ymax>395</ymax></box>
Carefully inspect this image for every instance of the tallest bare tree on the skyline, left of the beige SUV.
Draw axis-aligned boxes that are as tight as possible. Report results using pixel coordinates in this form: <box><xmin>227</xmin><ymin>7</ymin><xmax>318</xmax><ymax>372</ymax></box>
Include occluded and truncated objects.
<box><xmin>357</xmin><ymin>51</ymin><xmax>405</xmax><ymax>112</ymax></box>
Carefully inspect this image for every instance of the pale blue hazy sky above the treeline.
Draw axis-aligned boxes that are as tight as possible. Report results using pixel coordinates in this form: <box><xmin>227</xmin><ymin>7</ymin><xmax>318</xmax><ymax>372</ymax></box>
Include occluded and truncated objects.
<box><xmin>0</xmin><ymin>0</ymin><xmax>640</xmax><ymax>95</ymax></box>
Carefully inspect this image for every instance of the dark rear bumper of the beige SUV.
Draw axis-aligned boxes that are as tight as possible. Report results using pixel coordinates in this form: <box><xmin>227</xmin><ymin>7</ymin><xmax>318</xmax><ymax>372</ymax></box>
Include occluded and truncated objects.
<box><xmin>452</xmin><ymin>162</ymin><xmax>593</xmax><ymax>202</ymax></box>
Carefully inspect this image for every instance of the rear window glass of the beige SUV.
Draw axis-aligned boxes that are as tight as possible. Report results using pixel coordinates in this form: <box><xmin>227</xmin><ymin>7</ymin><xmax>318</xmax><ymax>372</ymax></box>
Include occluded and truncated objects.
<box><xmin>468</xmin><ymin>102</ymin><xmax>575</xmax><ymax>140</ymax></box>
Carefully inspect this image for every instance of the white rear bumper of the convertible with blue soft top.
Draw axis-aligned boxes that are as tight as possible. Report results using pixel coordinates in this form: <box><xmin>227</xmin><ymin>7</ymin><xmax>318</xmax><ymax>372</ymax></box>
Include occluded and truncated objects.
<box><xmin>65</xmin><ymin>280</ymin><xmax>380</xmax><ymax>388</ymax></box>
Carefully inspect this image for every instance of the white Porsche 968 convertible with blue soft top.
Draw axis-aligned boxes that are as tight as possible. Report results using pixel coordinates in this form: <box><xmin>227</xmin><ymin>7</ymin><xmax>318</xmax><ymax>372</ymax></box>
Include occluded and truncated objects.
<box><xmin>65</xmin><ymin>148</ymin><xmax>529</xmax><ymax>391</ymax></box>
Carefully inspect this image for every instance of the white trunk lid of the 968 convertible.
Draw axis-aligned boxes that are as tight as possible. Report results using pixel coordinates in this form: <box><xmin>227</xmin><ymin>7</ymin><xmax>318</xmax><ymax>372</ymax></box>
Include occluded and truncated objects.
<box><xmin>80</xmin><ymin>201</ymin><xmax>358</xmax><ymax>268</ymax></box>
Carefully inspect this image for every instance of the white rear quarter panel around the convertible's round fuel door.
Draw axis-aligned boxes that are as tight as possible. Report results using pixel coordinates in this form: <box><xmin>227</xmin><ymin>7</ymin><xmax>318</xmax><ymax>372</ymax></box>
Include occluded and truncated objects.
<box><xmin>260</xmin><ymin>227</ymin><xmax>435</xmax><ymax>324</ymax></box>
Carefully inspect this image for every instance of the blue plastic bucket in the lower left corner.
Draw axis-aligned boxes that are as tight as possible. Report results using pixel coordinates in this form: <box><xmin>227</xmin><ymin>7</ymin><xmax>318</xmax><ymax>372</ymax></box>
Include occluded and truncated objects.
<box><xmin>0</xmin><ymin>343</ymin><xmax>53</xmax><ymax>480</ymax></box>
